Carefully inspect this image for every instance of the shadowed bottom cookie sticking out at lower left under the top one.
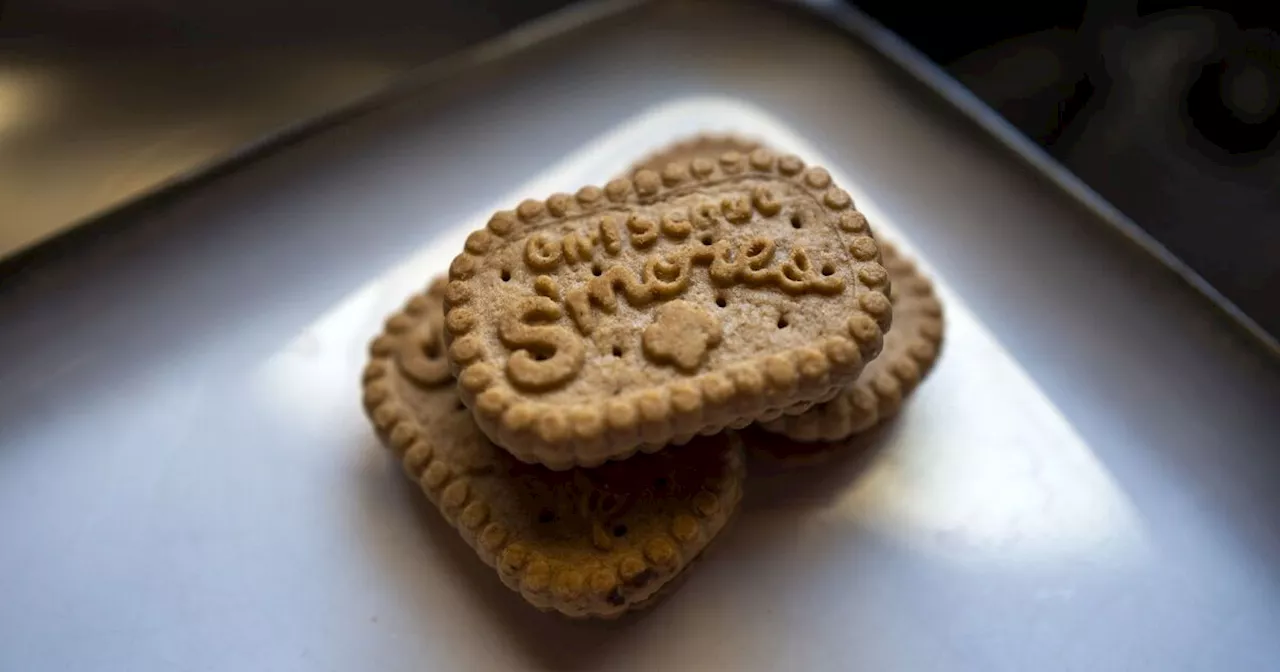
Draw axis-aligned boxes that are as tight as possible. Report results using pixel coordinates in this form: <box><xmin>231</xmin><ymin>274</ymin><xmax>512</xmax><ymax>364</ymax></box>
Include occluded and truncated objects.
<box><xmin>364</xmin><ymin>280</ymin><xmax>744</xmax><ymax>618</ymax></box>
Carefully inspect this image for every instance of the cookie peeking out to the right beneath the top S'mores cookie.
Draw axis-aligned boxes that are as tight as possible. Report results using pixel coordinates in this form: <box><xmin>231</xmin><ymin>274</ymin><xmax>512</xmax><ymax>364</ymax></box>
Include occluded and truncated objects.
<box><xmin>753</xmin><ymin>241</ymin><xmax>945</xmax><ymax>450</ymax></box>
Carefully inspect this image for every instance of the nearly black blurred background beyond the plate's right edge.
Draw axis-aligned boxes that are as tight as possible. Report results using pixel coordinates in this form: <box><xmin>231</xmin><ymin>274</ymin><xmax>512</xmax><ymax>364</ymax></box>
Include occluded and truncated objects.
<box><xmin>854</xmin><ymin>0</ymin><xmax>1280</xmax><ymax>343</ymax></box>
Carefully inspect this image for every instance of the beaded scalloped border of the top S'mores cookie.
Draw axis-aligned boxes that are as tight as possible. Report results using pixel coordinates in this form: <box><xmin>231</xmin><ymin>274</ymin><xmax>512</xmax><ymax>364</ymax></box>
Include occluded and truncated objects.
<box><xmin>444</xmin><ymin>150</ymin><xmax>892</xmax><ymax>470</ymax></box>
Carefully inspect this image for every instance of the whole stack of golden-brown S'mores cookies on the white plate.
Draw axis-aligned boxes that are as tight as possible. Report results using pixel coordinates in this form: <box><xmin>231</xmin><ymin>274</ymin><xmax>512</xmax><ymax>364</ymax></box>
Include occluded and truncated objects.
<box><xmin>364</xmin><ymin>136</ymin><xmax>942</xmax><ymax>617</ymax></box>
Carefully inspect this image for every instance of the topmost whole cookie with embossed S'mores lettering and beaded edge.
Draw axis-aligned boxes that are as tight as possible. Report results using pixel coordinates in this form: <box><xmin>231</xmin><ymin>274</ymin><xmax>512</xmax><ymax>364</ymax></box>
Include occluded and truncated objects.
<box><xmin>445</xmin><ymin>150</ymin><xmax>892</xmax><ymax>468</ymax></box>
